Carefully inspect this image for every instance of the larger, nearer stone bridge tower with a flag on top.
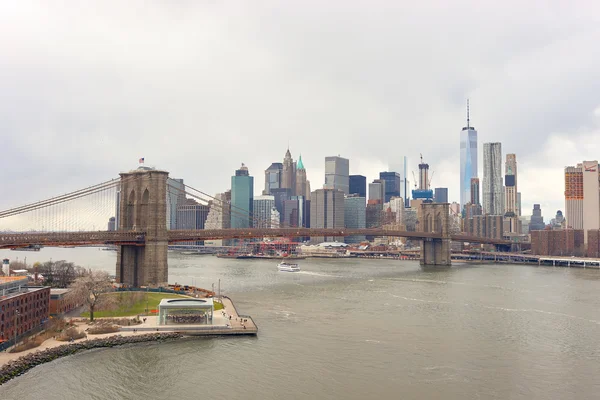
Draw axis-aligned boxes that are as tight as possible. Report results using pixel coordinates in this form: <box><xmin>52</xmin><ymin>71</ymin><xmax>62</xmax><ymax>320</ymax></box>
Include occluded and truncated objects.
<box><xmin>116</xmin><ymin>166</ymin><xmax>169</xmax><ymax>287</ymax></box>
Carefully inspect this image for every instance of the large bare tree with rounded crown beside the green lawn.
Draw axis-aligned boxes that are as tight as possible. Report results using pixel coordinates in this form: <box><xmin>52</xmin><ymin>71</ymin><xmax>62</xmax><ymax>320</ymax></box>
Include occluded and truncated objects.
<box><xmin>69</xmin><ymin>270</ymin><xmax>113</xmax><ymax>321</ymax></box>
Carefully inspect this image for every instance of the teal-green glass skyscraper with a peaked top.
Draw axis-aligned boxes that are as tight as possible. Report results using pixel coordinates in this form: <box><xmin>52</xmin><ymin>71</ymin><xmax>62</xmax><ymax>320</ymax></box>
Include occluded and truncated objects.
<box><xmin>231</xmin><ymin>164</ymin><xmax>254</xmax><ymax>228</ymax></box>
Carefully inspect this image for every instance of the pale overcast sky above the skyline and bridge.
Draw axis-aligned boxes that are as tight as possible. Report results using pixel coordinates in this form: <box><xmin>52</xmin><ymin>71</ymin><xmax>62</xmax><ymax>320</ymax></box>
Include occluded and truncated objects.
<box><xmin>0</xmin><ymin>0</ymin><xmax>600</xmax><ymax>220</ymax></box>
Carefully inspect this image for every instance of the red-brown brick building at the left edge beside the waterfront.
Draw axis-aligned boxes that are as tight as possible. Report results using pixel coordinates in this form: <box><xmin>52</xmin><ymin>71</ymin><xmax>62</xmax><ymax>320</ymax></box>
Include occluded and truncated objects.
<box><xmin>0</xmin><ymin>276</ymin><xmax>50</xmax><ymax>342</ymax></box>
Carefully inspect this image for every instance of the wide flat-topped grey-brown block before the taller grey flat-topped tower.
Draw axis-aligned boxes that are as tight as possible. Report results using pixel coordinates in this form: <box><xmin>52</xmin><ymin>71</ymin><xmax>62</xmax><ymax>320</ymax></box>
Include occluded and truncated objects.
<box><xmin>310</xmin><ymin>189</ymin><xmax>345</xmax><ymax>241</ymax></box>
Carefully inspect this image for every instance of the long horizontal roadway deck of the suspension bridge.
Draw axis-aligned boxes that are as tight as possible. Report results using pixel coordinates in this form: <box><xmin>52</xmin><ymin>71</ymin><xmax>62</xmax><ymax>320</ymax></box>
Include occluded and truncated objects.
<box><xmin>0</xmin><ymin>228</ymin><xmax>512</xmax><ymax>248</ymax></box>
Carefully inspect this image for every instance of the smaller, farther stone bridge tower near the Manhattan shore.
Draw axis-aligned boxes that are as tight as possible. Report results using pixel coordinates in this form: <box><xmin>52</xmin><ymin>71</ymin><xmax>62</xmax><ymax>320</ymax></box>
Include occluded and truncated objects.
<box><xmin>419</xmin><ymin>203</ymin><xmax>452</xmax><ymax>266</ymax></box>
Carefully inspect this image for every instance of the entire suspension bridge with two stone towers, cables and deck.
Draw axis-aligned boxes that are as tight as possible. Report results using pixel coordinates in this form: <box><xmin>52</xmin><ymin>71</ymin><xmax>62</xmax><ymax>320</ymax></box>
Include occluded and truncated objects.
<box><xmin>0</xmin><ymin>167</ymin><xmax>511</xmax><ymax>286</ymax></box>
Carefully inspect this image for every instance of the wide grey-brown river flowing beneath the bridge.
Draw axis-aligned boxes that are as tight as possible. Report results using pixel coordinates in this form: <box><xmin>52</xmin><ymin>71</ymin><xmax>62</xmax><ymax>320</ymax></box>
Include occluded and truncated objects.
<box><xmin>0</xmin><ymin>248</ymin><xmax>600</xmax><ymax>400</ymax></box>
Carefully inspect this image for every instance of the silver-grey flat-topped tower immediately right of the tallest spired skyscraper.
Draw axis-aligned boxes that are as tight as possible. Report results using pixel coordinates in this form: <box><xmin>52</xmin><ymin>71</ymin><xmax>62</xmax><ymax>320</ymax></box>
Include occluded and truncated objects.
<box><xmin>483</xmin><ymin>142</ymin><xmax>504</xmax><ymax>215</ymax></box>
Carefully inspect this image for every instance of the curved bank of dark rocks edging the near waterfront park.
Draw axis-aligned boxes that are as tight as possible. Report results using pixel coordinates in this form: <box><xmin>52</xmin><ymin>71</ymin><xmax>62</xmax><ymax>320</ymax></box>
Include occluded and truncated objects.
<box><xmin>0</xmin><ymin>332</ymin><xmax>183</xmax><ymax>385</ymax></box>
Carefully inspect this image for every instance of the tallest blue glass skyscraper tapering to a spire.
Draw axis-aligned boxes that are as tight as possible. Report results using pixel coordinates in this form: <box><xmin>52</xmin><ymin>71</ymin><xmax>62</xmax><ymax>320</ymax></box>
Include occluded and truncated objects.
<box><xmin>460</xmin><ymin>100</ymin><xmax>477</xmax><ymax>207</ymax></box>
